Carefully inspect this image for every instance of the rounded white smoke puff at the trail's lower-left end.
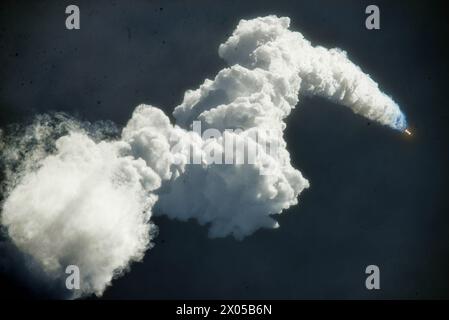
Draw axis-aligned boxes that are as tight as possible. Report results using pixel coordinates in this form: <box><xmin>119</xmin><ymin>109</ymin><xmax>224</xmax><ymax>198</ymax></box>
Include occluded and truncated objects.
<box><xmin>2</xmin><ymin>120</ymin><xmax>160</xmax><ymax>294</ymax></box>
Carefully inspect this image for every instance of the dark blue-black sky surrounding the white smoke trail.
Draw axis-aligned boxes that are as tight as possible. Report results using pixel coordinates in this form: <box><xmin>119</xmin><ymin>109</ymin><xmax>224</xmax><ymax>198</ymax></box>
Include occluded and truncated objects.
<box><xmin>0</xmin><ymin>0</ymin><xmax>449</xmax><ymax>299</ymax></box>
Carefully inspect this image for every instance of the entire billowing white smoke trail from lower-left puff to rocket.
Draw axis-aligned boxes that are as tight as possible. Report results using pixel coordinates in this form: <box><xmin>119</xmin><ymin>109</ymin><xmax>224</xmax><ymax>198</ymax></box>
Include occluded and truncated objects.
<box><xmin>1</xmin><ymin>16</ymin><xmax>406</xmax><ymax>295</ymax></box>
